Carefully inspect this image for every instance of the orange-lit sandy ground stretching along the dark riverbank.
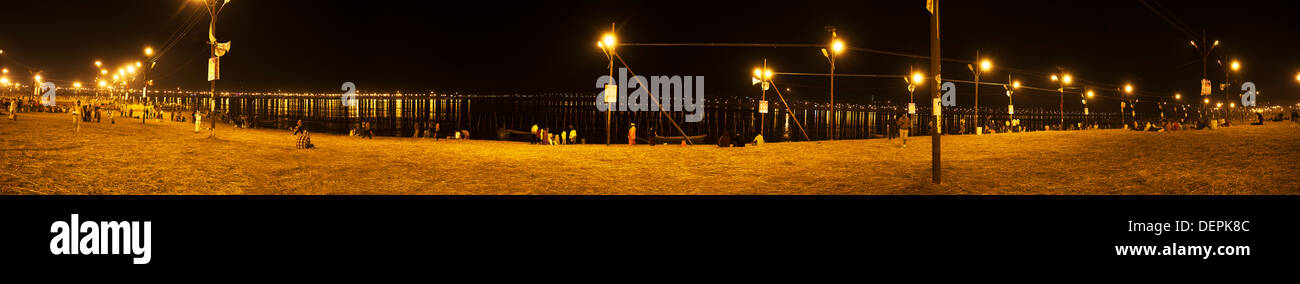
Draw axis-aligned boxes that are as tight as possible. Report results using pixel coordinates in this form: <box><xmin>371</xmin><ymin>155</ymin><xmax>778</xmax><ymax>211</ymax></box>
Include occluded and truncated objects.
<box><xmin>0</xmin><ymin>113</ymin><xmax>1300</xmax><ymax>194</ymax></box>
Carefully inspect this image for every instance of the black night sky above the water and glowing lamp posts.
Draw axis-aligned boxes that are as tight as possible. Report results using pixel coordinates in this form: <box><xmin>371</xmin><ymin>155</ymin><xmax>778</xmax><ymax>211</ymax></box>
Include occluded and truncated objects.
<box><xmin>0</xmin><ymin>0</ymin><xmax>1300</xmax><ymax>111</ymax></box>
